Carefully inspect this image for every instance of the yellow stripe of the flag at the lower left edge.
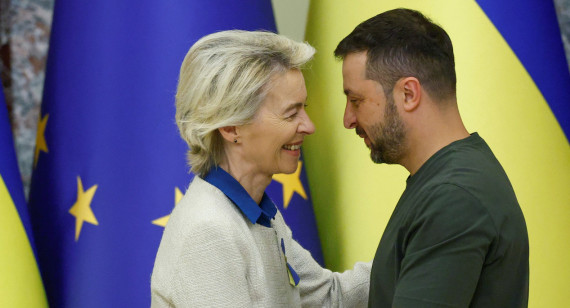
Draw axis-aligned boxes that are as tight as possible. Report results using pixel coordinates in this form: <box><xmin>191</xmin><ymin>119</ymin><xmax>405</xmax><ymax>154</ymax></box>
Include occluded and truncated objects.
<box><xmin>0</xmin><ymin>175</ymin><xmax>48</xmax><ymax>307</ymax></box>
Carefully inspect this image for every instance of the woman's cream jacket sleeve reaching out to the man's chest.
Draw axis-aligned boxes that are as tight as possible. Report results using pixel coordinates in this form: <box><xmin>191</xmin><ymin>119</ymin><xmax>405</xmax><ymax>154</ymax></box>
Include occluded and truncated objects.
<box><xmin>288</xmin><ymin>225</ymin><xmax>372</xmax><ymax>307</ymax></box>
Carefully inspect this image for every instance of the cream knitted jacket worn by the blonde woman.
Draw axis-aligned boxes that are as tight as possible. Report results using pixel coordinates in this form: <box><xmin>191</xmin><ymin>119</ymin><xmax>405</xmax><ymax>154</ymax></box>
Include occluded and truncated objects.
<box><xmin>151</xmin><ymin>177</ymin><xmax>371</xmax><ymax>307</ymax></box>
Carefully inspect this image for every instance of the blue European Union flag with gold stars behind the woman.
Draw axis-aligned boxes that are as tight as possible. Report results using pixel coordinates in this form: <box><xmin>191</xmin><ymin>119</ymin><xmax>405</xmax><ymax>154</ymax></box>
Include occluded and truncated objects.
<box><xmin>30</xmin><ymin>0</ymin><xmax>321</xmax><ymax>307</ymax></box>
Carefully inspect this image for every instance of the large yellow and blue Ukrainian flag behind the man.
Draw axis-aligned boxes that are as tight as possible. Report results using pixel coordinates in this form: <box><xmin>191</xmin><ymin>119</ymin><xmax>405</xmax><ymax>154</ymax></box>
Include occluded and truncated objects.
<box><xmin>305</xmin><ymin>0</ymin><xmax>570</xmax><ymax>307</ymax></box>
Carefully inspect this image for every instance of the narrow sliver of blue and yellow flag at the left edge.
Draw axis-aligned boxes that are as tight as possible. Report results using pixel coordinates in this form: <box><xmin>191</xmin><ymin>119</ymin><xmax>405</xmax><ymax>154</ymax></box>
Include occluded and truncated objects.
<box><xmin>0</xmin><ymin>83</ymin><xmax>47</xmax><ymax>307</ymax></box>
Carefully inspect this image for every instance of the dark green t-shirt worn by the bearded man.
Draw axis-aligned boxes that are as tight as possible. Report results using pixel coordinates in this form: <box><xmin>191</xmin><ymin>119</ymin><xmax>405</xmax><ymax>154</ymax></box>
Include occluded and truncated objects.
<box><xmin>369</xmin><ymin>133</ymin><xmax>529</xmax><ymax>308</ymax></box>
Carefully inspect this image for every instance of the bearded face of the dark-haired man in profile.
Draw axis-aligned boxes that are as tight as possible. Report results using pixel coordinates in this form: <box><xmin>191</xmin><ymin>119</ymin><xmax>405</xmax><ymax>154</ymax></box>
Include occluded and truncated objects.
<box><xmin>342</xmin><ymin>52</ymin><xmax>406</xmax><ymax>164</ymax></box>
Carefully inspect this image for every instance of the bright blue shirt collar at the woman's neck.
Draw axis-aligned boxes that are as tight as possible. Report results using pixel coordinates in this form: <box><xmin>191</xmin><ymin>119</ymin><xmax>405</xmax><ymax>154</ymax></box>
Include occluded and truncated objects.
<box><xmin>204</xmin><ymin>167</ymin><xmax>277</xmax><ymax>227</ymax></box>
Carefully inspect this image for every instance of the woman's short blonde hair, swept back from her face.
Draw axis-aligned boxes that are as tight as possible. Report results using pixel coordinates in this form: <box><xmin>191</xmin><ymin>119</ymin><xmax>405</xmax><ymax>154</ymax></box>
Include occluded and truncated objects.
<box><xmin>176</xmin><ymin>30</ymin><xmax>315</xmax><ymax>176</ymax></box>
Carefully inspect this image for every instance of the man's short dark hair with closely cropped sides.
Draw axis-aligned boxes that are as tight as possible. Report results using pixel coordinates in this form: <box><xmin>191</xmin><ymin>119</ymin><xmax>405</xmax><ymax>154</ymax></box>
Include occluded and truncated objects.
<box><xmin>334</xmin><ymin>9</ymin><xmax>456</xmax><ymax>100</ymax></box>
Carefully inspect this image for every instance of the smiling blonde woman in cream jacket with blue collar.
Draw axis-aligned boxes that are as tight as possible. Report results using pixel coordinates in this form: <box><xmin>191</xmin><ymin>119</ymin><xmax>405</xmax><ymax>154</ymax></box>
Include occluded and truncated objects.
<box><xmin>151</xmin><ymin>30</ymin><xmax>370</xmax><ymax>307</ymax></box>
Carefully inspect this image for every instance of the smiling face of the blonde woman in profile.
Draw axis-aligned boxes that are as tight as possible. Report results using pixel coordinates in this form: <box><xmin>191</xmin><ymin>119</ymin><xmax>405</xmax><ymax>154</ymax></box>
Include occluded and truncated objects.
<box><xmin>239</xmin><ymin>70</ymin><xmax>315</xmax><ymax>176</ymax></box>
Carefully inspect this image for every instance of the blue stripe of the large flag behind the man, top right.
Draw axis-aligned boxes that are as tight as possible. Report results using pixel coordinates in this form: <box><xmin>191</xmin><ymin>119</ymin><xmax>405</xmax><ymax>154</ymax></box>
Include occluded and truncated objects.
<box><xmin>476</xmin><ymin>0</ymin><xmax>570</xmax><ymax>140</ymax></box>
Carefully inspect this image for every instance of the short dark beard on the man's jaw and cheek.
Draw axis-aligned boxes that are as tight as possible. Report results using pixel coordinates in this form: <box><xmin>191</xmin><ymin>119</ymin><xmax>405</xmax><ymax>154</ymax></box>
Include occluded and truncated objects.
<box><xmin>357</xmin><ymin>95</ymin><xmax>406</xmax><ymax>164</ymax></box>
